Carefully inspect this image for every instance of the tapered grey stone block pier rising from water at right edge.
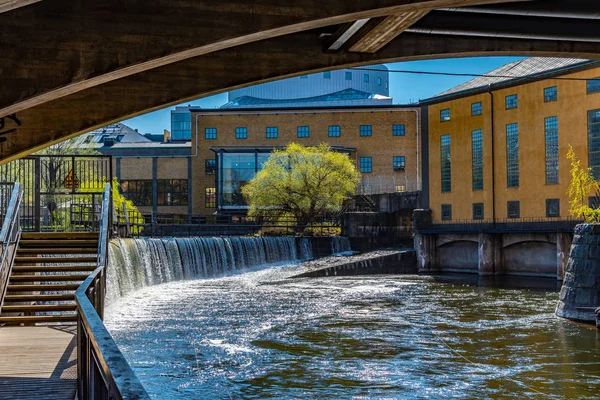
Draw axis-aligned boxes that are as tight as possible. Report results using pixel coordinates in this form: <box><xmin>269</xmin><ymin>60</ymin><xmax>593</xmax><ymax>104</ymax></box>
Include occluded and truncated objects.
<box><xmin>556</xmin><ymin>224</ymin><xmax>600</xmax><ymax>324</ymax></box>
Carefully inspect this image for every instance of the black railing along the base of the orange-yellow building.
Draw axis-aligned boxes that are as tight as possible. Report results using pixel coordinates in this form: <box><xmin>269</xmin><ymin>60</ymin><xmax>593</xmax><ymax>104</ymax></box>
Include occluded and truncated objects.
<box><xmin>415</xmin><ymin>217</ymin><xmax>583</xmax><ymax>234</ymax></box>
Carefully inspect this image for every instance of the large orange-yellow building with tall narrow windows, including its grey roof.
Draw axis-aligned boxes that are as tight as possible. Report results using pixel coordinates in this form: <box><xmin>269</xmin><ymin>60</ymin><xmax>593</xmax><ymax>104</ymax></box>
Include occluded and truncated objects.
<box><xmin>422</xmin><ymin>58</ymin><xmax>600</xmax><ymax>221</ymax></box>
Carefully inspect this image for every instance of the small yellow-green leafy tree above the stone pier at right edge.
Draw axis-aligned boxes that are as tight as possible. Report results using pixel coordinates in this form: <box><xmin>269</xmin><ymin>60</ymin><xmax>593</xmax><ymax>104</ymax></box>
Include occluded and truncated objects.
<box><xmin>567</xmin><ymin>145</ymin><xmax>600</xmax><ymax>223</ymax></box>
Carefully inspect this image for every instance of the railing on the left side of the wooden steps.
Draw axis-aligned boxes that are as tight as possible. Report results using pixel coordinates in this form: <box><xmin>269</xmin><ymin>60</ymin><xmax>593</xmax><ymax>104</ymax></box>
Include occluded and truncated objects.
<box><xmin>0</xmin><ymin>183</ymin><xmax>23</xmax><ymax>309</ymax></box>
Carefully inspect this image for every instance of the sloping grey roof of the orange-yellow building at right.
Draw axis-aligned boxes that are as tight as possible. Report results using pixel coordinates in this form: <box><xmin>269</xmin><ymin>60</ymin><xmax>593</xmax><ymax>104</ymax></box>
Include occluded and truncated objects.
<box><xmin>434</xmin><ymin>57</ymin><xmax>595</xmax><ymax>102</ymax></box>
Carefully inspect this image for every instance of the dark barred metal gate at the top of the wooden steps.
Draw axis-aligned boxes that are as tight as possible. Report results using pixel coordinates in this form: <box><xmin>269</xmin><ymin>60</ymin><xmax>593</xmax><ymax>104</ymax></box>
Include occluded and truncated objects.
<box><xmin>0</xmin><ymin>155</ymin><xmax>112</xmax><ymax>232</ymax></box>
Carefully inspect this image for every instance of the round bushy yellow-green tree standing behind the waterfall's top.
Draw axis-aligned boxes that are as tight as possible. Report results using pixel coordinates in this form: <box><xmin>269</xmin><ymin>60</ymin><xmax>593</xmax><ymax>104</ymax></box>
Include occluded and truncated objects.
<box><xmin>242</xmin><ymin>143</ymin><xmax>360</xmax><ymax>233</ymax></box>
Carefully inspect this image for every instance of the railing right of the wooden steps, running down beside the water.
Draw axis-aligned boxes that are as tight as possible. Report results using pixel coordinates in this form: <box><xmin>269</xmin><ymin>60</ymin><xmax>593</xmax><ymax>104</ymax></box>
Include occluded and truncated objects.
<box><xmin>75</xmin><ymin>184</ymin><xmax>150</xmax><ymax>400</ymax></box>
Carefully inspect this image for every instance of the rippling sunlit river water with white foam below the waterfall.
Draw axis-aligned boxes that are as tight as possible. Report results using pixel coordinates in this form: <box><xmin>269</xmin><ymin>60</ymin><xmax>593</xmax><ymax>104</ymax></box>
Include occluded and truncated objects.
<box><xmin>106</xmin><ymin>239</ymin><xmax>600</xmax><ymax>399</ymax></box>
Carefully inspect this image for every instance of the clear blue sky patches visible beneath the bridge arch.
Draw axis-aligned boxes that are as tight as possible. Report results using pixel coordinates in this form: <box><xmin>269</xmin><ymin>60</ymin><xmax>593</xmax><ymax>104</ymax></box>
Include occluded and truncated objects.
<box><xmin>123</xmin><ymin>57</ymin><xmax>523</xmax><ymax>133</ymax></box>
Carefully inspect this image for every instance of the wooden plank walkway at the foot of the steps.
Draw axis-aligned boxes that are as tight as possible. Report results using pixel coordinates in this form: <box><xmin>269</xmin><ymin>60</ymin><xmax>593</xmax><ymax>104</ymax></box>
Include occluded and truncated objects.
<box><xmin>0</xmin><ymin>326</ymin><xmax>77</xmax><ymax>400</ymax></box>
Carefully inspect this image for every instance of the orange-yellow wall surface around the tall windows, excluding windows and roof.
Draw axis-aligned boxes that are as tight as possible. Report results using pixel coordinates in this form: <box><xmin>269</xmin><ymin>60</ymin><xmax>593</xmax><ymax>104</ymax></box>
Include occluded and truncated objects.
<box><xmin>428</xmin><ymin>68</ymin><xmax>600</xmax><ymax>220</ymax></box>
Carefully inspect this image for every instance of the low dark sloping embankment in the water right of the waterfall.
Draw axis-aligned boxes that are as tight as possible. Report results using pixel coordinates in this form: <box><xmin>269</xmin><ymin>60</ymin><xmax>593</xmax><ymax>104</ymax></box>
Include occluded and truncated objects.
<box><xmin>291</xmin><ymin>249</ymin><xmax>417</xmax><ymax>278</ymax></box>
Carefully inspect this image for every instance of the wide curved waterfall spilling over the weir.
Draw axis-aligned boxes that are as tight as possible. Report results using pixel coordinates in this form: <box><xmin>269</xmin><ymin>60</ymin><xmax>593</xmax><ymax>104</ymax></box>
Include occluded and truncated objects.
<box><xmin>106</xmin><ymin>236</ymin><xmax>304</xmax><ymax>303</ymax></box>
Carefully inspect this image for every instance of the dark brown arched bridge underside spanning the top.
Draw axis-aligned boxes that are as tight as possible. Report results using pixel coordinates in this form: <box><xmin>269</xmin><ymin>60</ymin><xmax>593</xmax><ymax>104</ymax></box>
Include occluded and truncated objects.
<box><xmin>0</xmin><ymin>0</ymin><xmax>600</xmax><ymax>164</ymax></box>
